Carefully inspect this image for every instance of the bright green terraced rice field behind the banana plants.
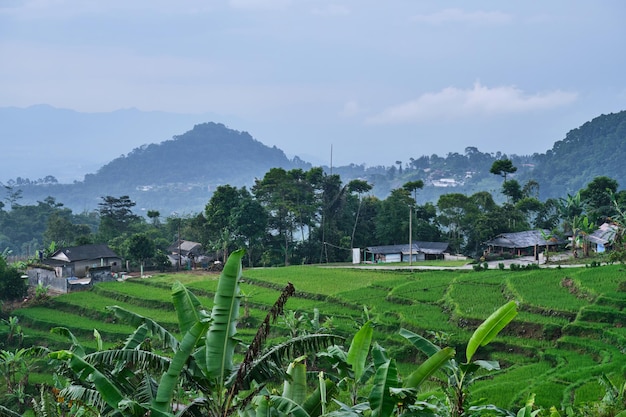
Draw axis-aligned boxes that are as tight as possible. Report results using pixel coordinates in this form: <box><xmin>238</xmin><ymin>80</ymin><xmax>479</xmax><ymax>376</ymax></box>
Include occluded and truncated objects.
<box><xmin>6</xmin><ymin>265</ymin><xmax>626</xmax><ymax>409</ymax></box>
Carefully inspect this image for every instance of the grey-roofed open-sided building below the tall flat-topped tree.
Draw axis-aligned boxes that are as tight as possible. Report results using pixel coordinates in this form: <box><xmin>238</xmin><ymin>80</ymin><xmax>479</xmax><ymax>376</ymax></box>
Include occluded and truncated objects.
<box><xmin>484</xmin><ymin>230</ymin><xmax>565</xmax><ymax>256</ymax></box>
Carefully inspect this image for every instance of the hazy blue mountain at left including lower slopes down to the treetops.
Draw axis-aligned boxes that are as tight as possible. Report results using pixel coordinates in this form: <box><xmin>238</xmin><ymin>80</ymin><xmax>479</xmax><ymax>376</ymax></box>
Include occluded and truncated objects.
<box><xmin>15</xmin><ymin>123</ymin><xmax>310</xmax><ymax>216</ymax></box>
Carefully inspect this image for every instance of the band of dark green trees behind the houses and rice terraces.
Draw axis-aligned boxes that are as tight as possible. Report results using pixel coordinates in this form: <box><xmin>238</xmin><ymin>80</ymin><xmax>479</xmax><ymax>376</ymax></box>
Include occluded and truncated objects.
<box><xmin>0</xmin><ymin>158</ymin><xmax>626</xmax><ymax>266</ymax></box>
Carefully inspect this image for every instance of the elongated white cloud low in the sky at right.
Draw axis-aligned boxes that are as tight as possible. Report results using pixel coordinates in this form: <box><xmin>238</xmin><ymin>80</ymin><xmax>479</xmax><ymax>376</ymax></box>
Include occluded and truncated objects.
<box><xmin>368</xmin><ymin>82</ymin><xmax>577</xmax><ymax>124</ymax></box>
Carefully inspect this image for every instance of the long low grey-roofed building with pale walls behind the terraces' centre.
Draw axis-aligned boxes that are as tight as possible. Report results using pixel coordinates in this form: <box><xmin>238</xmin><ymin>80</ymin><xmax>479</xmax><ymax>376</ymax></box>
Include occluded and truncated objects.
<box><xmin>364</xmin><ymin>242</ymin><xmax>449</xmax><ymax>263</ymax></box>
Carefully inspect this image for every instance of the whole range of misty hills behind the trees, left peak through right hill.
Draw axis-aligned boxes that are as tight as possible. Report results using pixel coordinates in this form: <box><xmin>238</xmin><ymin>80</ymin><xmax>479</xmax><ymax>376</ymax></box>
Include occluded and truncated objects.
<box><xmin>1</xmin><ymin>106</ymin><xmax>626</xmax><ymax>214</ymax></box>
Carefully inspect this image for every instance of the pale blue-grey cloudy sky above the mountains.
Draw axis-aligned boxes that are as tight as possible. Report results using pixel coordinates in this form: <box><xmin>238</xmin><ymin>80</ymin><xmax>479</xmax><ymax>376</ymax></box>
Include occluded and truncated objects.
<box><xmin>0</xmin><ymin>0</ymin><xmax>626</xmax><ymax>165</ymax></box>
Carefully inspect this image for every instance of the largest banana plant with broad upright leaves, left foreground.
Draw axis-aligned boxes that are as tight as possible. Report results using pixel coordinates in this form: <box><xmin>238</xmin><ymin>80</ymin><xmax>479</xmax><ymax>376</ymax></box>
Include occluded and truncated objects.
<box><xmin>50</xmin><ymin>250</ymin><xmax>337</xmax><ymax>417</ymax></box>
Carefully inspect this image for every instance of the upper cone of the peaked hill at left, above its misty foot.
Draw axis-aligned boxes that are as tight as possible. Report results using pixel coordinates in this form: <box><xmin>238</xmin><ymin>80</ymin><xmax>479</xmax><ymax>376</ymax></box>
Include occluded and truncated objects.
<box><xmin>84</xmin><ymin>123</ymin><xmax>302</xmax><ymax>189</ymax></box>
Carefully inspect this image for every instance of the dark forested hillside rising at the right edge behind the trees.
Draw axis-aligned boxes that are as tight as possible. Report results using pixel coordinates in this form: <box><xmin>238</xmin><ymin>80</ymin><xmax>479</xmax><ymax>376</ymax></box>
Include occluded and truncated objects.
<box><xmin>530</xmin><ymin>111</ymin><xmax>626</xmax><ymax>199</ymax></box>
